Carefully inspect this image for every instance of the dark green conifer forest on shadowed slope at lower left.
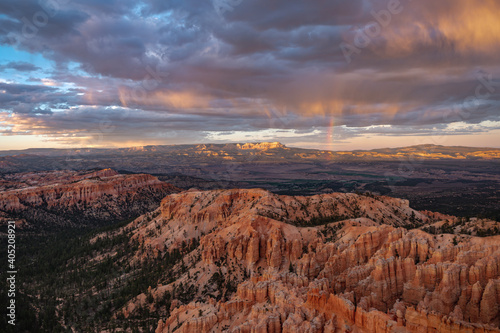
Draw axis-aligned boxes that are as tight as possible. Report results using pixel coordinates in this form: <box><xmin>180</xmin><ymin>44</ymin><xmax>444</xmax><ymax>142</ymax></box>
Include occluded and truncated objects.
<box><xmin>0</xmin><ymin>220</ymin><xmax>199</xmax><ymax>332</ymax></box>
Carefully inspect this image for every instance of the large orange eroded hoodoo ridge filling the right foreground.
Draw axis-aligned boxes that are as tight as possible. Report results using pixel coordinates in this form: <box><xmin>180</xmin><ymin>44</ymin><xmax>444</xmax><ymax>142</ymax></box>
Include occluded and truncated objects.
<box><xmin>118</xmin><ymin>190</ymin><xmax>500</xmax><ymax>333</ymax></box>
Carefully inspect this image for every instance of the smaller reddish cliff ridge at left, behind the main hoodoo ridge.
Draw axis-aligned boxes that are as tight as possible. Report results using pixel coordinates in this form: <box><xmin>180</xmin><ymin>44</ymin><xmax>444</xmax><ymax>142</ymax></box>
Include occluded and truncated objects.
<box><xmin>0</xmin><ymin>169</ymin><xmax>178</xmax><ymax>225</ymax></box>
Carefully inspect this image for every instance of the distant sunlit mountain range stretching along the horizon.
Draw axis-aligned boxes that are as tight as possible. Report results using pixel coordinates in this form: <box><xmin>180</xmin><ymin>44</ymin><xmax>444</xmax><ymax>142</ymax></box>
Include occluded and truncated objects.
<box><xmin>0</xmin><ymin>142</ymin><xmax>500</xmax><ymax>161</ymax></box>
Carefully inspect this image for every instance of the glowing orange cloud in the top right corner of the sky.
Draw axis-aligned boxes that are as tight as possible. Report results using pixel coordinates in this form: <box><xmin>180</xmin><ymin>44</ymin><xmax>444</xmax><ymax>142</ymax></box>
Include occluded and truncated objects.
<box><xmin>347</xmin><ymin>0</ymin><xmax>500</xmax><ymax>58</ymax></box>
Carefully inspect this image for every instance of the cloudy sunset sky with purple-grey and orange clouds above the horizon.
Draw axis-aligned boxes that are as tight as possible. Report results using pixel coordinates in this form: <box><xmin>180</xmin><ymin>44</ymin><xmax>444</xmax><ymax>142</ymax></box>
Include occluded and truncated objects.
<box><xmin>0</xmin><ymin>0</ymin><xmax>500</xmax><ymax>150</ymax></box>
